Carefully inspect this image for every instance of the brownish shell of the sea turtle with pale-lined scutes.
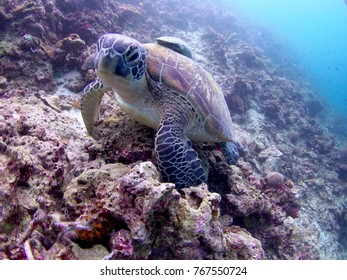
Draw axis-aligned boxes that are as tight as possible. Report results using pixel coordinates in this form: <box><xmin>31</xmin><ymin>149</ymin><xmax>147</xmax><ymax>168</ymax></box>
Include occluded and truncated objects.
<box><xmin>145</xmin><ymin>44</ymin><xmax>233</xmax><ymax>142</ymax></box>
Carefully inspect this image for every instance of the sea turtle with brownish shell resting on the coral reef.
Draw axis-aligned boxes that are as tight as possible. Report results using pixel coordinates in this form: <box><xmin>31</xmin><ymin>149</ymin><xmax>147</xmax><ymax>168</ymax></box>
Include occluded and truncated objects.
<box><xmin>81</xmin><ymin>33</ymin><xmax>237</xmax><ymax>188</ymax></box>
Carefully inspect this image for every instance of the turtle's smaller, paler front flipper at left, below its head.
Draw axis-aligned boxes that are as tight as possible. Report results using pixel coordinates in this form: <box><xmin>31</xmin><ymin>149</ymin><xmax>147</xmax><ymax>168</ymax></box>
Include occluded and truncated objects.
<box><xmin>81</xmin><ymin>79</ymin><xmax>108</xmax><ymax>137</ymax></box>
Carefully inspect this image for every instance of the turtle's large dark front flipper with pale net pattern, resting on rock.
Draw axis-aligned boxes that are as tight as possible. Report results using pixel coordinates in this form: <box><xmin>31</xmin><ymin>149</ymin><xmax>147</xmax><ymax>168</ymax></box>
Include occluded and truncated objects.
<box><xmin>155</xmin><ymin>112</ymin><xmax>207</xmax><ymax>188</ymax></box>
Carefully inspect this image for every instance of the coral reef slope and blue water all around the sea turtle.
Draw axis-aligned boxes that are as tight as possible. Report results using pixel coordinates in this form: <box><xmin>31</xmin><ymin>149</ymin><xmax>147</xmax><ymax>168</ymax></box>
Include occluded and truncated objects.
<box><xmin>0</xmin><ymin>0</ymin><xmax>347</xmax><ymax>260</ymax></box>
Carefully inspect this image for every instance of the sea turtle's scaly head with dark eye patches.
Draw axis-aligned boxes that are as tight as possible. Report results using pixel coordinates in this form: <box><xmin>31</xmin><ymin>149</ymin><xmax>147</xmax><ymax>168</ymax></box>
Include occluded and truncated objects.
<box><xmin>94</xmin><ymin>33</ymin><xmax>147</xmax><ymax>87</ymax></box>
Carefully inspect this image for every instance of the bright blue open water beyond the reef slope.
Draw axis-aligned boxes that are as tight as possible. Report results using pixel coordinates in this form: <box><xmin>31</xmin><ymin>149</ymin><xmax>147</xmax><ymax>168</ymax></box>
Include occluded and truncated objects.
<box><xmin>224</xmin><ymin>0</ymin><xmax>347</xmax><ymax>116</ymax></box>
